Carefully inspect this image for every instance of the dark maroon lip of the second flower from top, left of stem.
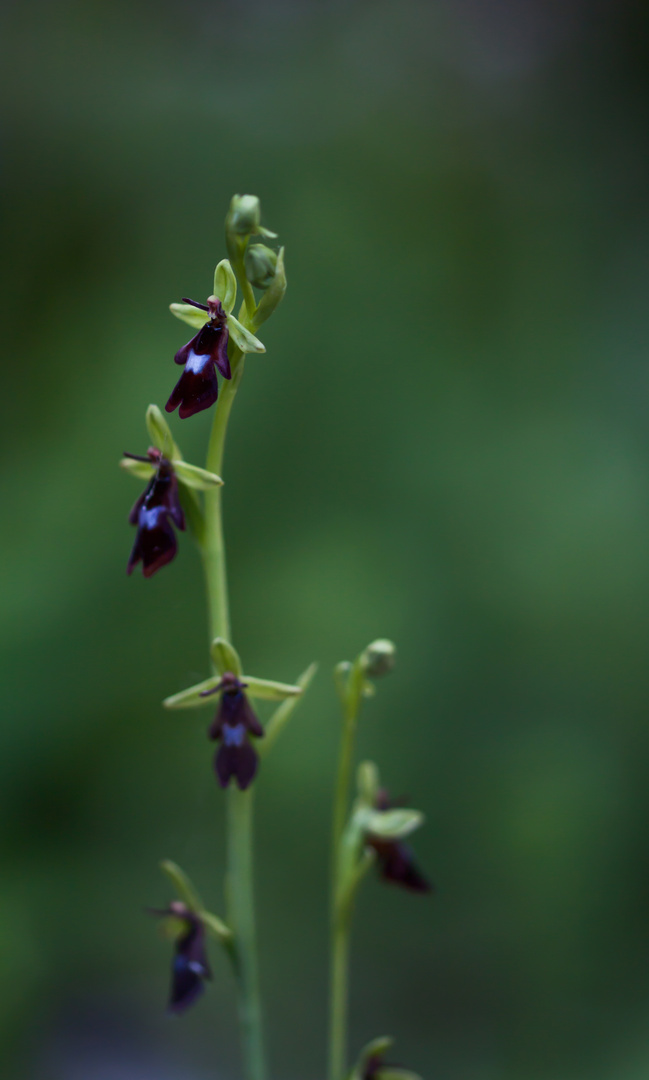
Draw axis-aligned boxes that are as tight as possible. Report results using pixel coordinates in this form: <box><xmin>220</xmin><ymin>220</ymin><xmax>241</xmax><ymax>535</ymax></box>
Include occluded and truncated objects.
<box><xmin>124</xmin><ymin>446</ymin><xmax>185</xmax><ymax>578</ymax></box>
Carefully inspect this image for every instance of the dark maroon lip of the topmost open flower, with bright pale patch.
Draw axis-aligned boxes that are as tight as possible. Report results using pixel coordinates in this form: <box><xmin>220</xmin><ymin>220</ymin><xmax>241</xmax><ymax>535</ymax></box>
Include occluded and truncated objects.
<box><xmin>164</xmin><ymin>296</ymin><xmax>232</xmax><ymax>420</ymax></box>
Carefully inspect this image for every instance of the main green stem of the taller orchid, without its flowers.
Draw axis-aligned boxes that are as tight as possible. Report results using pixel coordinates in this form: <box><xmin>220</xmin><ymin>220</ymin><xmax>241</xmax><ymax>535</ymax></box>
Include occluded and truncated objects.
<box><xmin>203</xmin><ymin>350</ymin><xmax>266</xmax><ymax>1080</ymax></box>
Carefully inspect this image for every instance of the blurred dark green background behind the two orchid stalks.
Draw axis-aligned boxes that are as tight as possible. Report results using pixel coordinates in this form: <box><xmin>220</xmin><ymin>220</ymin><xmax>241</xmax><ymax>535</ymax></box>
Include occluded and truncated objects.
<box><xmin>0</xmin><ymin>0</ymin><xmax>649</xmax><ymax>1080</ymax></box>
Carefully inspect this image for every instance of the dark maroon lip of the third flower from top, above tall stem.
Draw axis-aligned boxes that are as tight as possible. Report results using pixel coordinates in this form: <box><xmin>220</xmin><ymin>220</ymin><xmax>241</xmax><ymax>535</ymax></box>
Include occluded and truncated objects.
<box><xmin>202</xmin><ymin>672</ymin><xmax>263</xmax><ymax>791</ymax></box>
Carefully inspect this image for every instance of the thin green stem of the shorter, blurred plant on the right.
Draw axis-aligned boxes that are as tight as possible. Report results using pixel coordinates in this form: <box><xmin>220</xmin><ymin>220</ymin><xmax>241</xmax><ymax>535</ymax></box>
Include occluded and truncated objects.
<box><xmin>328</xmin><ymin>664</ymin><xmax>362</xmax><ymax>1080</ymax></box>
